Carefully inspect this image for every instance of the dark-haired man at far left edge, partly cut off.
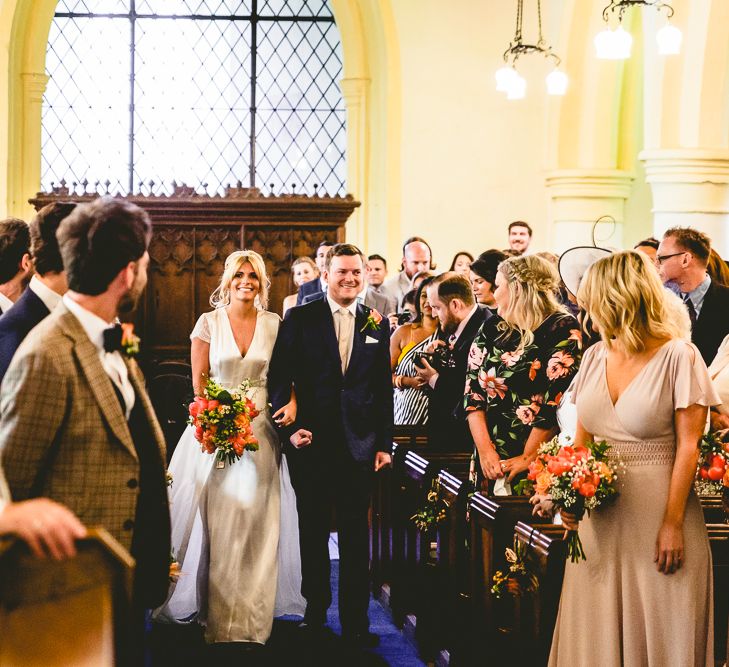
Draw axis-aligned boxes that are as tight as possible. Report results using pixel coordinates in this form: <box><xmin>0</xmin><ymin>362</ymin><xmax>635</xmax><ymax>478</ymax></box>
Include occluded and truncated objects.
<box><xmin>0</xmin><ymin>218</ymin><xmax>33</xmax><ymax>315</ymax></box>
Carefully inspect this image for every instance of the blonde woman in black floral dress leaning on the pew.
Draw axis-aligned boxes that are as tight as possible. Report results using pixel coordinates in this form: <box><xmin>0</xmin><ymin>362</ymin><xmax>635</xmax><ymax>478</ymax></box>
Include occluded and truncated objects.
<box><xmin>465</xmin><ymin>255</ymin><xmax>580</xmax><ymax>494</ymax></box>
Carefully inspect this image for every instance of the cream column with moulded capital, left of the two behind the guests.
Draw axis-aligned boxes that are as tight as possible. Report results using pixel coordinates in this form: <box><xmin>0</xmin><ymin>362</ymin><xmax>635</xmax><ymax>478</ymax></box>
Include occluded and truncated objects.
<box><xmin>546</xmin><ymin>169</ymin><xmax>633</xmax><ymax>253</ymax></box>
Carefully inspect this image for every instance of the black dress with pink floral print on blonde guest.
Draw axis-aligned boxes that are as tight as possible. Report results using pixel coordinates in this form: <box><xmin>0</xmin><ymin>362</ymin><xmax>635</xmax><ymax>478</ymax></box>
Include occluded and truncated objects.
<box><xmin>464</xmin><ymin>313</ymin><xmax>581</xmax><ymax>470</ymax></box>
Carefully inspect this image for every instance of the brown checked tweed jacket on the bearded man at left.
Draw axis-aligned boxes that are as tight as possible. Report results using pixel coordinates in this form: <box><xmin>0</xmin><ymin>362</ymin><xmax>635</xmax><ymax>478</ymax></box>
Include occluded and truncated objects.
<box><xmin>0</xmin><ymin>304</ymin><xmax>166</xmax><ymax>549</ymax></box>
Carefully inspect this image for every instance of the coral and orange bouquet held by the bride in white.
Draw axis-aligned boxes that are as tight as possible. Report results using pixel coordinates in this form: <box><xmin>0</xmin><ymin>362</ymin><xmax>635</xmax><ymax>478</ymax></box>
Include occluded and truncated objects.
<box><xmin>188</xmin><ymin>378</ymin><xmax>259</xmax><ymax>468</ymax></box>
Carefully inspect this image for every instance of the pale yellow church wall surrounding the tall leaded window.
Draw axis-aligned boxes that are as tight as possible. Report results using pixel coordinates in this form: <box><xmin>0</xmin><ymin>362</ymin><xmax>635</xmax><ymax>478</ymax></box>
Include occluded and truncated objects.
<box><xmin>0</xmin><ymin>0</ymin><xmax>729</xmax><ymax>260</ymax></box>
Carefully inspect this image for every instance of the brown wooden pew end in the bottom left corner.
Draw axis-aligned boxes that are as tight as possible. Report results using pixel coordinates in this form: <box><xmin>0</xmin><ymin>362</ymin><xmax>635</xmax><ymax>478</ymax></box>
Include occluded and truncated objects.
<box><xmin>0</xmin><ymin>528</ymin><xmax>134</xmax><ymax>667</ymax></box>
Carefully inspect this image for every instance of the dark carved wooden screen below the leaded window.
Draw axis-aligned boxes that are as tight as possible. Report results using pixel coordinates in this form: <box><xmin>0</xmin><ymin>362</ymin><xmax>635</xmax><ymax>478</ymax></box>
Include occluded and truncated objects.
<box><xmin>30</xmin><ymin>185</ymin><xmax>359</xmax><ymax>365</ymax></box>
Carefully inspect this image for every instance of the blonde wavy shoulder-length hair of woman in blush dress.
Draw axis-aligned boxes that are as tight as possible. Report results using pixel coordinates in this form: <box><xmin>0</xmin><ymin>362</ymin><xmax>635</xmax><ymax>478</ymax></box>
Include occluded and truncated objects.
<box><xmin>577</xmin><ymin>250</ymin><xmax>691</xmax><ymax>354</ymax></box>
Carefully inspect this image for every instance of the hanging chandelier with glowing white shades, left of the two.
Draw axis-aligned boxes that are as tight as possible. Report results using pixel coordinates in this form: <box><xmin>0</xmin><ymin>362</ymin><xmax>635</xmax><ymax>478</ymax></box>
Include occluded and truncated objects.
<box><xmin>496</xmin><ymin>0</ymin><xmax>567</xmax><ymax>100</ymax></box>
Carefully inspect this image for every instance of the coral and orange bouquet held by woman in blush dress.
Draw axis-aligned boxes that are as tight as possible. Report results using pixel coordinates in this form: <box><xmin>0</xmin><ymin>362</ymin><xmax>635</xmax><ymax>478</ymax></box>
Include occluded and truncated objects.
<box><xmin>516</xmin><ymin>437</ymin><xmax>618</xmax><ymax>563</ymax></box>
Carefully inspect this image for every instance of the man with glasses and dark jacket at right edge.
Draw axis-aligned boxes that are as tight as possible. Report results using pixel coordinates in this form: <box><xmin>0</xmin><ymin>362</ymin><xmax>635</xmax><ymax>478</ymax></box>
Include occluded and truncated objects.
<box><xmin>655</xmin><ymin>227</ymin><xmax>729</xmax><ymax>365</ymax></box>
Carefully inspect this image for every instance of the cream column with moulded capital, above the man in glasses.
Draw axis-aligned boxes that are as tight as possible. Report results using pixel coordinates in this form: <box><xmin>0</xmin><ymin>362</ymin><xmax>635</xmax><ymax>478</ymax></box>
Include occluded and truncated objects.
<box><xmin>639</xmin><ymin>148</ymin><xmax>729</xmax><ymax>257</ymax></box>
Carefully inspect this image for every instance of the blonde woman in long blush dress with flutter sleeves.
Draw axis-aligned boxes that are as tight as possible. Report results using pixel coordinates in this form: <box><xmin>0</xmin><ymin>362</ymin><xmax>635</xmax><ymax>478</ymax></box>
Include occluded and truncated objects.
<box><xmin>549</xmin><ymin>251</ymin><xmax>718</xmax><ymax>667</ymax></box>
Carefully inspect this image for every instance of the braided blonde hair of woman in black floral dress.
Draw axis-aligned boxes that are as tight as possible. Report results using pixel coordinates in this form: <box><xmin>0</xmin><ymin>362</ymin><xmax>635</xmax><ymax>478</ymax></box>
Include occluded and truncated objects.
<box><xmin>498</xmin><ymin>255</ymin><xmax>569</xmax><ymax>348</ymax></box>
